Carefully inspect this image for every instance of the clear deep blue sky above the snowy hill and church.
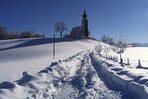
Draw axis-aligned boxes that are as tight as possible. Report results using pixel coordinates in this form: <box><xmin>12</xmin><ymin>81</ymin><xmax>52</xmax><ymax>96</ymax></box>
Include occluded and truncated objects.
<box><xmin>0</xmin><ymin>0</ymin><xmax>148</xmax><ymax>43</ymax></box>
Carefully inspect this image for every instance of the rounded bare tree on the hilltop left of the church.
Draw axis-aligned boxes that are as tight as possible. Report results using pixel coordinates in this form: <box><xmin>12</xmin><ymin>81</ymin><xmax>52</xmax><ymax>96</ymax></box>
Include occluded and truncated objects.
<box><xmin>55</xmin><ymin>21</ymin><xmax>67</xmax><ymax>39</ymax></box>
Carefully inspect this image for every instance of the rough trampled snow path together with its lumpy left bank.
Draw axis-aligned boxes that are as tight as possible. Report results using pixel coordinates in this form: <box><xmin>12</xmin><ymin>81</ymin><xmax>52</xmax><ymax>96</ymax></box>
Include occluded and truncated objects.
<box><xmin>0</xmin><ymin>51</ymin><xmax>122</xmax><ymax>99</ymax></box>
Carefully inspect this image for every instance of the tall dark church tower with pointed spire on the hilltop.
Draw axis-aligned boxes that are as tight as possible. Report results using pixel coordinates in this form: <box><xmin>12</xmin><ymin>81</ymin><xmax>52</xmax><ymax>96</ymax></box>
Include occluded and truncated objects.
<box><xmin>82</xmin><ymin>10</ymin><xmax>89</xmax><ymax>37</ymax></box>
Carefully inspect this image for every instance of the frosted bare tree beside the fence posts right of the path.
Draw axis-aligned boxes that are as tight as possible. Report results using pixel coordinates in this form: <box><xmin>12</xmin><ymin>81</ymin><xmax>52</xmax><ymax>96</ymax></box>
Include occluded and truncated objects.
<box><xmin>113</xmin><ymin>40</ymin><xmax>127</xmax><ymax>66</ymax></box>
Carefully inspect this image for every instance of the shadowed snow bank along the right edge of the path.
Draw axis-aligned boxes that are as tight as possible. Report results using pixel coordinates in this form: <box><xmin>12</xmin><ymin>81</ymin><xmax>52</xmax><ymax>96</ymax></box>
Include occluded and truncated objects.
<box><xmin>91</xmin><ymin>46</ymin><xmax>148</xmax><ymax>99</ymax></box>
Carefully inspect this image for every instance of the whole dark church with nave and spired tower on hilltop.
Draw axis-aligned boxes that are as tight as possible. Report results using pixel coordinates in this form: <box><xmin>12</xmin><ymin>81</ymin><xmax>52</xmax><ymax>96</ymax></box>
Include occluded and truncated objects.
<box><xmin>69</xmin><ymin>10</ymin><xmax>90</xmax><ymax>38</ymax></box>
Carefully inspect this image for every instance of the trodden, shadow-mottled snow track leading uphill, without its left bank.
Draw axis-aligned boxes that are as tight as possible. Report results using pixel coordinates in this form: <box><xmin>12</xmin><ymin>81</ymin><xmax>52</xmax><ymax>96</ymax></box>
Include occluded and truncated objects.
<box><xmin>54</xmin><ymin>53</ymin><xmax>121</xmax><ymax>99</ymax></box>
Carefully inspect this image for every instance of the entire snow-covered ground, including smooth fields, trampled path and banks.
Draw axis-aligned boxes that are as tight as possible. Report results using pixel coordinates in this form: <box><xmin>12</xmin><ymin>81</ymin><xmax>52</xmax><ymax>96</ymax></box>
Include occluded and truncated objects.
<box><xmin>0</xmin><ymin>38</ymin><xmax>148</xmax><ymax>99</ymax></box>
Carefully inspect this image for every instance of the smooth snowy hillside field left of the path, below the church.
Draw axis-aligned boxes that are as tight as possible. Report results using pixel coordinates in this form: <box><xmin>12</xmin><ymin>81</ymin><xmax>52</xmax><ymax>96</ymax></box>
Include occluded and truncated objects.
<box><xmin>0</xmin><ymin>38</ymin><xmax>97</xmax><ymax>81</ymax></box>
